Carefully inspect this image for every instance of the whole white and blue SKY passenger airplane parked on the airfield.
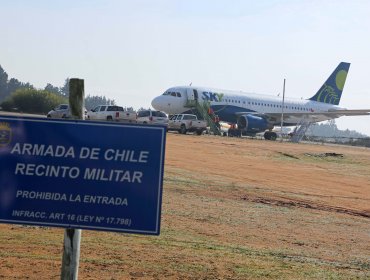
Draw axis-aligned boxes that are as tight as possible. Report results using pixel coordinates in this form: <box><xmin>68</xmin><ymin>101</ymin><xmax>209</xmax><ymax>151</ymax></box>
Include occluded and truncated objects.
<box><xmin>152</xmin><ymin>62</ymin><xmax>370</xmax><ymax>139</ymax></box>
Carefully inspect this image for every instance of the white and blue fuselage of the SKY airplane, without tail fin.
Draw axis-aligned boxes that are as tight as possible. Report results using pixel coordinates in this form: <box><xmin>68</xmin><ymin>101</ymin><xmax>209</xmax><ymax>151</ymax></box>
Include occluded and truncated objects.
<box><xmin>152</xmin><ymin>86</ymin><xmax>344</xmax><ymax>125</ymax></box>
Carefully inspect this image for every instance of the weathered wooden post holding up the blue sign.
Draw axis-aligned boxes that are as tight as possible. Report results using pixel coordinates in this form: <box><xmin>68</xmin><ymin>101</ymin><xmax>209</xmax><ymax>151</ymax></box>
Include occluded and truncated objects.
<box><xmin>60</xmin><ymin>79</ymin><xmax>85</xmax><ymax>280</ymax></box>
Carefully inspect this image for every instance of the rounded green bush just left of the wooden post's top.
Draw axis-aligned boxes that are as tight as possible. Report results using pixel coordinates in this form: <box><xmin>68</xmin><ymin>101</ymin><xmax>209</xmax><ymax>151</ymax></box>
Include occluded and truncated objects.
<box><xmin>1</xmin><ymin>89</ymin><xmax>67</xmax><ymax>114</ymax></box>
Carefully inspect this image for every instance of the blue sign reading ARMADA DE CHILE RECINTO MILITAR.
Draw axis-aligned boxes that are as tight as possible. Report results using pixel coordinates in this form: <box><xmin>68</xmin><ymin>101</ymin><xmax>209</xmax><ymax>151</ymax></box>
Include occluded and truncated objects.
<box><xmin>0</xmin><ymin>117</ymin><xmax>166</xmax><ymax>235</ymax></box>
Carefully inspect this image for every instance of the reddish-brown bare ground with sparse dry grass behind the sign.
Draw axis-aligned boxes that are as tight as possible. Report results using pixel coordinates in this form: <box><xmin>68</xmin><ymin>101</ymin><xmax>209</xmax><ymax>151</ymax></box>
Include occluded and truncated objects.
<box><xmin>0</xmin><ymin>133</ymin><xmax>370</xmax><ymax>279</ymax></box>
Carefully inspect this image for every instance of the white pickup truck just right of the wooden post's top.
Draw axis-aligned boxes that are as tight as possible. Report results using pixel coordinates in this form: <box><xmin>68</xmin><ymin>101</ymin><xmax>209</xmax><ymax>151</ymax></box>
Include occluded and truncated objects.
<box><xmin>87</xmin><ymin>105</ymin><xmax>137</xmax><ymax>122</ymax></box>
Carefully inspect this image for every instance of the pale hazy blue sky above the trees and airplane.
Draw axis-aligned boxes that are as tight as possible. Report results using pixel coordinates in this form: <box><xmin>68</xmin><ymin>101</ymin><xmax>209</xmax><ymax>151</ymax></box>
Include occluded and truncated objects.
<box><xmin>0</xmin><ymin>0</ymin><xmax>370</xmax><ymax>135</ymax></box>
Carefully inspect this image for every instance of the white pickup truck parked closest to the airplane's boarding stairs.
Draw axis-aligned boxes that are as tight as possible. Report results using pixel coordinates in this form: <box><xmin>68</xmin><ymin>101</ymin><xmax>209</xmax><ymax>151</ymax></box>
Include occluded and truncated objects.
<box><xmin>167</xmin><ymin>114</ymin><xmax>207</xmax><ymax>135</ymax></box>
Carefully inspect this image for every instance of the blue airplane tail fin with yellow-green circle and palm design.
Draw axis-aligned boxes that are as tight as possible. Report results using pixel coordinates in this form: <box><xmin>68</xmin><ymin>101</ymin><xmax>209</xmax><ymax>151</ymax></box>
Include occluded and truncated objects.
<box><xmin>309</xmin><ymin>62</ymin><xmax>350</xmax><ymax>105</ymax></box>
